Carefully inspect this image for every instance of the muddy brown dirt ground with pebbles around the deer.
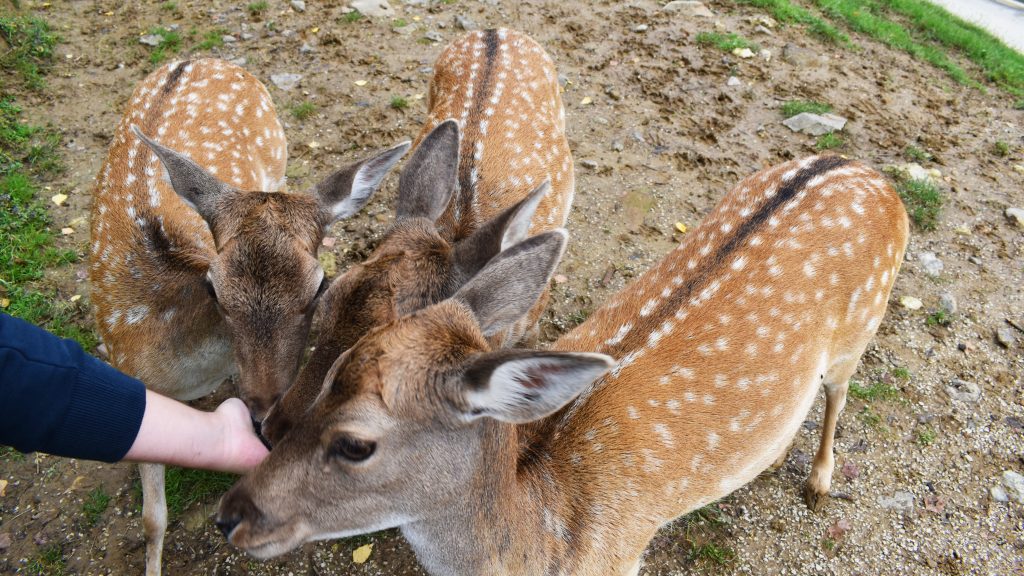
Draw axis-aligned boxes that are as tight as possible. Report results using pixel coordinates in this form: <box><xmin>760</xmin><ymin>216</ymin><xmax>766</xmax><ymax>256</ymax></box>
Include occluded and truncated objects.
<box><xmin>0</xmin><ymin>0</ymin><xmax>1024</xmax><ymax>575</ymax></box>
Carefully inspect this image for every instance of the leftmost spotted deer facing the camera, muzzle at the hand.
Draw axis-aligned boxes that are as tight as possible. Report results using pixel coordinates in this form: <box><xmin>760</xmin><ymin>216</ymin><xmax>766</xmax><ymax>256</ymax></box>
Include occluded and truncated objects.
<box><xmin>90</xmin><ymin>58</ymin><xmax>410</xmax><ymax>576</ymax></box>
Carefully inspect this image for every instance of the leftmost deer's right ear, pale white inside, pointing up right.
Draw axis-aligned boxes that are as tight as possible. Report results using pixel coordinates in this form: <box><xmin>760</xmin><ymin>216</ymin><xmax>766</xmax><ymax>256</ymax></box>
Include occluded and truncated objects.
<box><xmin>312</xmin><ymin>141</ymin><xmax>410</xmax><ymax>222</ymax></box>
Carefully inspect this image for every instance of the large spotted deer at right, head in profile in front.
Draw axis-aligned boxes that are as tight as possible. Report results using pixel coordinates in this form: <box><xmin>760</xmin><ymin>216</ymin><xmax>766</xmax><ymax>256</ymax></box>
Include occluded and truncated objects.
<box><xmin>218</xmin><ymin>156</ymin><xmax>907</xmax><ymax>576</ymax></box>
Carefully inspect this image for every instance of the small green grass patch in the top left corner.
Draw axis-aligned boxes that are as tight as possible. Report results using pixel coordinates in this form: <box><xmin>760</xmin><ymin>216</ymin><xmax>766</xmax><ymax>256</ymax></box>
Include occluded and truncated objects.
<box><xmin>0</xmin><ymin>16</ymin><xmax>59</xmax><ymax>90</ymax></box>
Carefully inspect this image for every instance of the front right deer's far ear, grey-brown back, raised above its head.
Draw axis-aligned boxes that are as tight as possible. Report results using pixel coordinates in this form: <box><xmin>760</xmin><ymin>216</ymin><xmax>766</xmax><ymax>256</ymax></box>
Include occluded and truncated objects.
<box><xmin>452</xmin><ymin>229</ymin><xmax>568</xmax><ymax>336</ymax></box>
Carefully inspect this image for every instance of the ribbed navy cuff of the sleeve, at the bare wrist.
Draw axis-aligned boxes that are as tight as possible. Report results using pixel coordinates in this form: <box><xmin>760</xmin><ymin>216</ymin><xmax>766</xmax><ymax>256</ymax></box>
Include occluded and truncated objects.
<box><xmin>48</xmin><ymin>357</ymin><xmax>145</xmax><ymax>462</ymax></box>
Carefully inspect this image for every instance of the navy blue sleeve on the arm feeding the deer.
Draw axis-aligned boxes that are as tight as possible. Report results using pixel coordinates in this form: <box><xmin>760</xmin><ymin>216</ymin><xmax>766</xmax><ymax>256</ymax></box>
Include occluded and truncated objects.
<box><xmin>0</xmin><ymin>314</ymin><xmax>145</xmax><ymax>462</ymax></box>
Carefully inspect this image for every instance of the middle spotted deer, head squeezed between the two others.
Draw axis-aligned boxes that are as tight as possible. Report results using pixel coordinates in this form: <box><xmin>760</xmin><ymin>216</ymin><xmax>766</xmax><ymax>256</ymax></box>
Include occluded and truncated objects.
<box><xmin>261</xmin><ymin>29</ymin><xmax>575</xmax><ymax>444</ymax></box>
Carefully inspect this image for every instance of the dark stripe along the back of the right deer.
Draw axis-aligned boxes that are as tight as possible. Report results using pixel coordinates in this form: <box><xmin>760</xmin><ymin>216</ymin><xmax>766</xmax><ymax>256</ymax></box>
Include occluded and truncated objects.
<box><xmin>603</xmin><ymin>156</ymin><xmax>850</xmax><ymax>358</ymax></box>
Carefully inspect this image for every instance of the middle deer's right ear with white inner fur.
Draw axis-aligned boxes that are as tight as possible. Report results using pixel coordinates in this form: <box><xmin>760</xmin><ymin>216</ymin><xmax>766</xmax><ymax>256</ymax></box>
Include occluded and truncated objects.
<box><xmin>453</xmin><ymin>181</ymin><xmax>551</xmax><ymax>276</ymax></box>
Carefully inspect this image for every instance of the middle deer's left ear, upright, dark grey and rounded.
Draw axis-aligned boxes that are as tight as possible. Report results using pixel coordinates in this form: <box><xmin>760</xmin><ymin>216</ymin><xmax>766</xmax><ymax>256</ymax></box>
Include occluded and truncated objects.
<box><xmin>395</xmin><ymin>120</ymin><xmax>459</xmax><ymax>220</ymax></box>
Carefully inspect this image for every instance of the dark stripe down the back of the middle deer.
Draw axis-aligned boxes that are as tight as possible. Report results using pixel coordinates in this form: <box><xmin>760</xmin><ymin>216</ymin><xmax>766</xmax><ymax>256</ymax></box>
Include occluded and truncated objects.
<box><xmin>454</xmin><ymin>29</ymin><xmax>500</xmax><ymax>240</ymax></box>
